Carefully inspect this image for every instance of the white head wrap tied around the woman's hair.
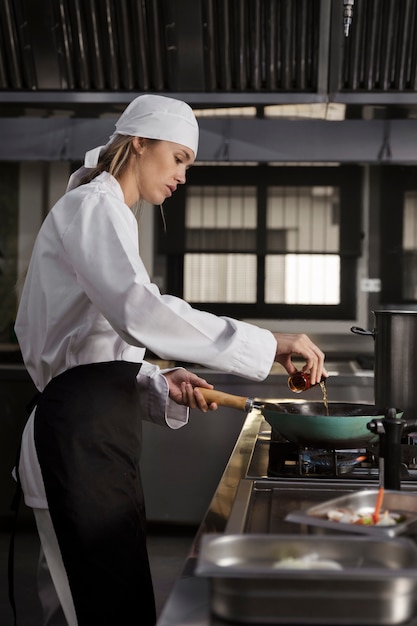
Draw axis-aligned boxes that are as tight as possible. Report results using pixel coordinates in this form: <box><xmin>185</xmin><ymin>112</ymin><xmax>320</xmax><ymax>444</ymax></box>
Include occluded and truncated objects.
<box><xmin>67</xmin><ymin>94</ymin><xmax>198</xmax><ymax>191</ymax></box>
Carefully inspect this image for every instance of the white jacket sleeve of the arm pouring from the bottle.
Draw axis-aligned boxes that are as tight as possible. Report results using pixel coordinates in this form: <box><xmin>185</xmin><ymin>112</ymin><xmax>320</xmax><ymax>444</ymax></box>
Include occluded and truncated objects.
<box><xmin>62</xmin><ymin>194</ymin><xmax>276</xmax><ymax>380</ymax></box>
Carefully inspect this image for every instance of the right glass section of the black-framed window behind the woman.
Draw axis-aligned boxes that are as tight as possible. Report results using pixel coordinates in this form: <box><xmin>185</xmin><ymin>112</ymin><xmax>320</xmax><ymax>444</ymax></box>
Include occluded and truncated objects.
<box><xmin>265</xmin><ymin>185</ymin><xmax>340</xmax><ymax>304</ymax></box>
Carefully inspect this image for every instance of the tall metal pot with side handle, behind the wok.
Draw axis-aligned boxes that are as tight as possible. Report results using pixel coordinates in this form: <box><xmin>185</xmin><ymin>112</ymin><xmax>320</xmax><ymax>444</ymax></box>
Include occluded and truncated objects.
<box><xmin>351</xmin><ymin>310</ymin><xmax>417</xmax><ymax>419</ymax></box>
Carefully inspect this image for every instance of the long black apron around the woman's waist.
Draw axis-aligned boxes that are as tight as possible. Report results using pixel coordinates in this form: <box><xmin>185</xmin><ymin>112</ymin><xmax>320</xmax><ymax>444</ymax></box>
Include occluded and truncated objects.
<box><xmin>34</xmin><ymin>361</ymin><xmax>156</xmax><ymax>626</ymax></box>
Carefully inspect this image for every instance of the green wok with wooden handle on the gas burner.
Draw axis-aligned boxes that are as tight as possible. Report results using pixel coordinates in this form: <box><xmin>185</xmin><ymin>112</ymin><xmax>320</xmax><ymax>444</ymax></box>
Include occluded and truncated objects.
<box><xmin>199</xmin><ymin>387</ymin><xmax>402</xmax><ymax>449</ymax></box>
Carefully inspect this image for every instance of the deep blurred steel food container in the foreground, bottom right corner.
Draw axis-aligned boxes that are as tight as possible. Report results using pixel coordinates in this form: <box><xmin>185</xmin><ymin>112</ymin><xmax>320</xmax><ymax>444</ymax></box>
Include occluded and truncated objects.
<box><xmin>196</xmin><ymin>534</ymin><xmax>417</xmax><ymax>626</ymax></box>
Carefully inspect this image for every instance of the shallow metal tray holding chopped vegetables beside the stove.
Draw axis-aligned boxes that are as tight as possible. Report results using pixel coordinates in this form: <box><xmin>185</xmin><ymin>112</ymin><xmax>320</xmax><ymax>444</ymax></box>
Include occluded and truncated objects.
<box><xmin>285</xmin><ymin>489</ymin><xmax>417</xmax><ymax>537</ymax></box>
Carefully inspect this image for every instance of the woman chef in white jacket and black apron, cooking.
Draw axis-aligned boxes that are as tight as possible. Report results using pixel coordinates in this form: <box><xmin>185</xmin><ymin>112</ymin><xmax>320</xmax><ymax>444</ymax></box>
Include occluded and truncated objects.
<box><xmin>15</xmin><ymin>95</ymin><xmax>326</xmax><ymax>626</ymax></box>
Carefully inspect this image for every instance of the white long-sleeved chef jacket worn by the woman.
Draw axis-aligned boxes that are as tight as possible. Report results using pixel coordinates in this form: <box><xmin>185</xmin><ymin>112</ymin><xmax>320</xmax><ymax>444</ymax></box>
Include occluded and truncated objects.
<box><xmin>15</xmin><ymin>172</ymin><xmax>276</xmax><ymax>508</ymax></box>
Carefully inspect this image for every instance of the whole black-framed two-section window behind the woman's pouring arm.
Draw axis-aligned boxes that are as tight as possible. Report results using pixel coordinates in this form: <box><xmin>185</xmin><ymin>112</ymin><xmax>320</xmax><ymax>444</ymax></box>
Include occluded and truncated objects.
<box><xmin>159</xmin><ymin>166</ymin><xmax>360</xmax><ymax>319</ymax></box>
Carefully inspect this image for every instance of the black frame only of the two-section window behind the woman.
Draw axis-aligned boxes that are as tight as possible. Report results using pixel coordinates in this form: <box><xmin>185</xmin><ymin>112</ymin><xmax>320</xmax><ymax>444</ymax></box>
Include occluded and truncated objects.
<box><xmin>156</xmin><ymin>164</ymin><xmax>362</xmax><ymax>320</ymax></box>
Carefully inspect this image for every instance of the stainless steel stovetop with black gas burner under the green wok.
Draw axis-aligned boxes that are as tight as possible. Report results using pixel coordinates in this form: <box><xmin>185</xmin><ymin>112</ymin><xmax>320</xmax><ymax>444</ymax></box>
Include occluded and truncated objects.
<box><xmin>224</xmin><ymin>422</ymin><xmax>417</xmax><ymax>626</ymax></box>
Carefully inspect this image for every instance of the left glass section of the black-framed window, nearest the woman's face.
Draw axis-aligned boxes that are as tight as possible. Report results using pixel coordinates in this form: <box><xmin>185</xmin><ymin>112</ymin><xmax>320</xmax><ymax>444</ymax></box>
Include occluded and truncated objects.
<box><xmin>184</xmin><ymin>186</ymin><xmax>257</xmax><ymax>303</ymax></box>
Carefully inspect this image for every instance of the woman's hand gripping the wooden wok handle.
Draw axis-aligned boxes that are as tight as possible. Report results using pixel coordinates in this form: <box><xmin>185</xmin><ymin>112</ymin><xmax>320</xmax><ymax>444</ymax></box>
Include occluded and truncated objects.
<box><xmin>164</xmin><ymin>368</ymin><xmax>217</xmax><ymax>413</ymax></box>
